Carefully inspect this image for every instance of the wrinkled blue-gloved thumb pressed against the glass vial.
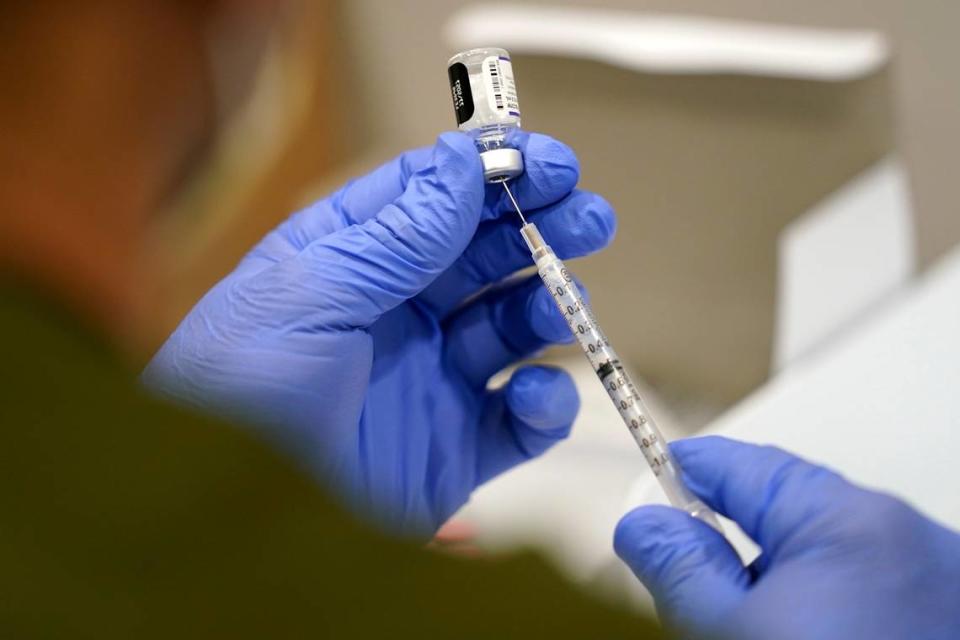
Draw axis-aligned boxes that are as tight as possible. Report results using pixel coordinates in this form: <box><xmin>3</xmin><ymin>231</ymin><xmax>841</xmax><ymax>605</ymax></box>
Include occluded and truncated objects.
<box><xmin>234</xmin><ymin>135</ymin><xmax>485</xmax><ymax>330</ymax></box>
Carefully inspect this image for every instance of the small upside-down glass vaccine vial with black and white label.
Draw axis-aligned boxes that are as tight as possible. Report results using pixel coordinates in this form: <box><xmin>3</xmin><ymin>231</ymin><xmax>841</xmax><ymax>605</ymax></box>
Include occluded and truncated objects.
<box><xmin>447</xmin><ymin>47</ymin><xmax>523</xmax><ymax>182</ymax></box>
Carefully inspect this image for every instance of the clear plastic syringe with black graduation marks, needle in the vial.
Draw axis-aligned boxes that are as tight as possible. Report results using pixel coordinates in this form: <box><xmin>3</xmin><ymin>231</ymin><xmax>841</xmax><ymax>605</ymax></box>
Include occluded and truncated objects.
<box><xmin>501</xmin><ymin>180</ymin><xmax>723</xmax><ymax>533</ymax></box>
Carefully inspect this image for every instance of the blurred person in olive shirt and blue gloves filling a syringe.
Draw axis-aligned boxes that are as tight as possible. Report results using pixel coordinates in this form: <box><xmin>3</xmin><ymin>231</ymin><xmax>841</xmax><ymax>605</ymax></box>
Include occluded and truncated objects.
<box><xmin>0</xmin><ymin>0</ymin><xmax>960</xmax><ymax>639</ymax></box>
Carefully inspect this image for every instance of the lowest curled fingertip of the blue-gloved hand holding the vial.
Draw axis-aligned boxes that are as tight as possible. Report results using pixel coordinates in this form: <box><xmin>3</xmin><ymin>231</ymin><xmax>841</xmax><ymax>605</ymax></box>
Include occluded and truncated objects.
<box><xmin>506</xmin><ymin>366</ymin><xmax>580</xmax><ymax>431</ymax></box>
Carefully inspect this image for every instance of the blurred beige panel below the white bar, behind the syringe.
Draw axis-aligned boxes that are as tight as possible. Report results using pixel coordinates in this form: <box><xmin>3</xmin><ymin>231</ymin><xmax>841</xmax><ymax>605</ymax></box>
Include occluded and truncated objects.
<box><xmin>517</xmin><ymin>57</ymin><xmax>892</xmax><ymax>402</ymax></box>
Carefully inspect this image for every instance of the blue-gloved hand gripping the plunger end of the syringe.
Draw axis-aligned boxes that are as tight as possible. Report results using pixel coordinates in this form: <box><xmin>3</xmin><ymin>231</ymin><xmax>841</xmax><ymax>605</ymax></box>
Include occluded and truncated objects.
<box><xmin>614</xmin><ymin>437</ymin><xmax>960</xmax><ymax>640</ymax></box>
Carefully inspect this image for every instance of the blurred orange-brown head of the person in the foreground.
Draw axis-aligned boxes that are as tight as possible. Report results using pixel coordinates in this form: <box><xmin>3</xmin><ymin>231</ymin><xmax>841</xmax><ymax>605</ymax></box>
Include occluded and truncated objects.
<box><xmin>0</xmin><ymin>0</ymin><xmax>283</xmax><ymax>344</ymax></box>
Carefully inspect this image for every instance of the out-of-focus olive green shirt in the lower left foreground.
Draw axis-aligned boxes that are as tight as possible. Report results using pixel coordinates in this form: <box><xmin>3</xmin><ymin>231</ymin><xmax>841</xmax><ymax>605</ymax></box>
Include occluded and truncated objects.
<box><xmin>0</xmin><ymin>288</ymin><xmax>660</xmax><ymax>640</ymax></box>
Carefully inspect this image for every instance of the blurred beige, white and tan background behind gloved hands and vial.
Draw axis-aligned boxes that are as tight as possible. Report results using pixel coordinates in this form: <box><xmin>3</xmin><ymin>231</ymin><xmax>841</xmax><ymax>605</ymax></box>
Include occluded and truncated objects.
<box><xmin>146</xmin><ymin>0</ymin><xmax>960</xmax><ymax>606</ymax></box>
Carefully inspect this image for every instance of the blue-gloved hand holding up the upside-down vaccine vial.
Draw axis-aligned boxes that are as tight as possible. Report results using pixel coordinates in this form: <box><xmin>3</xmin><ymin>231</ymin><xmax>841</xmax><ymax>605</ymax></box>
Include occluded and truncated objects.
<box><xmin>144</xmin><ymin>133</ymin><xmax>615</xmax><ymax>534</ymax></box>
